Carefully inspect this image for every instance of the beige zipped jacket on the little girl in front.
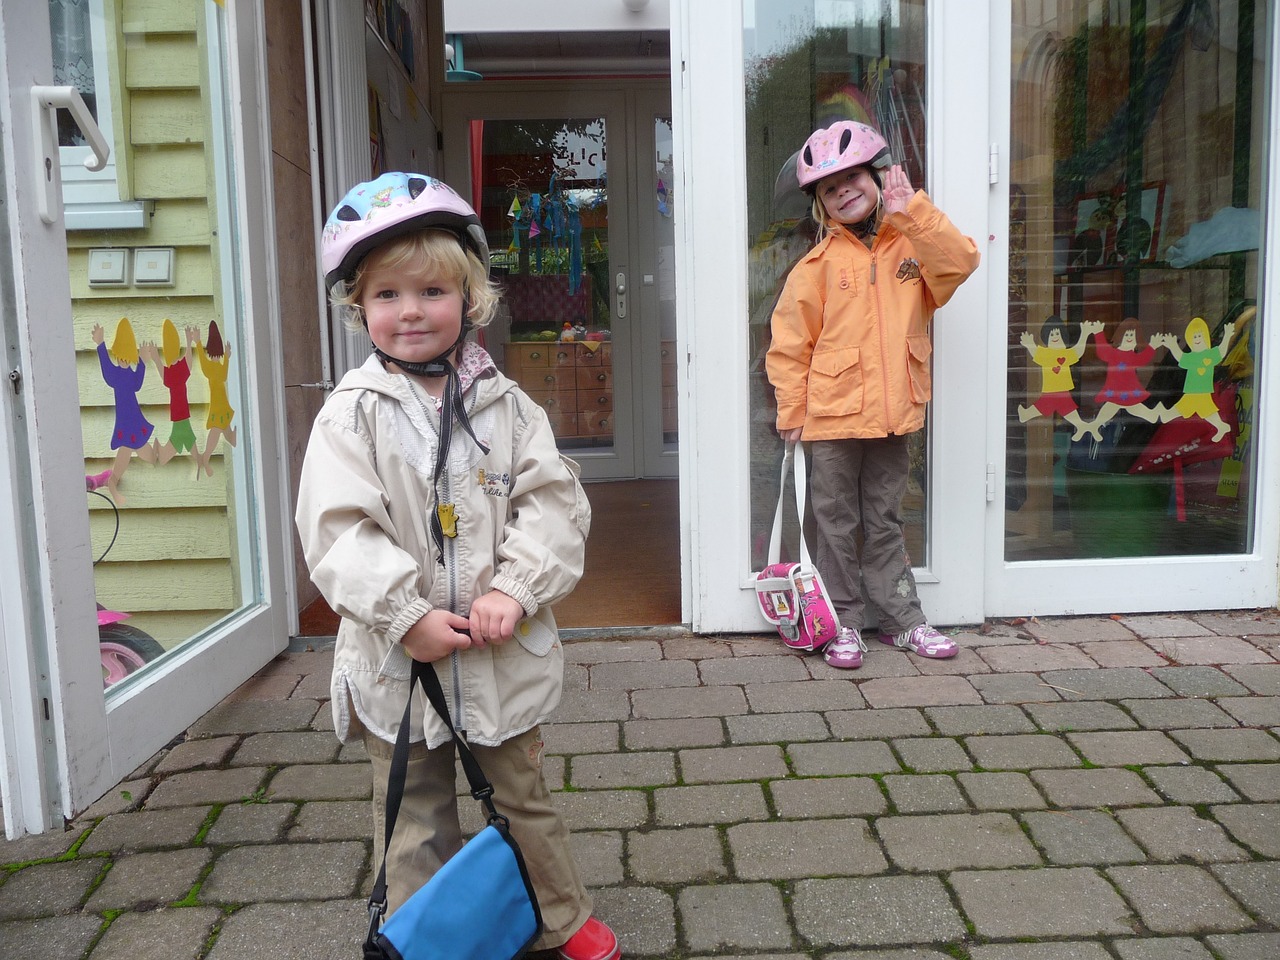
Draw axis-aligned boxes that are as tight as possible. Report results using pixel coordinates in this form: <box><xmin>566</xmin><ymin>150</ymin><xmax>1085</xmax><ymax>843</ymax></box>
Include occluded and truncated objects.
<box><xmin>296</xmin><ymin>357</ymin><xmax>591</xmax><ymax>746</ymax></box>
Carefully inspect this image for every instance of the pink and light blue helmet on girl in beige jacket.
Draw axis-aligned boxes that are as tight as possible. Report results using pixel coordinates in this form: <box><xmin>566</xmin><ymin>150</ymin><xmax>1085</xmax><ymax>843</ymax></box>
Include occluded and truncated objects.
<box><xmin>320</xmin><ymin>173</ymin><xmax>489</xmax><ymax>287</ymax></box>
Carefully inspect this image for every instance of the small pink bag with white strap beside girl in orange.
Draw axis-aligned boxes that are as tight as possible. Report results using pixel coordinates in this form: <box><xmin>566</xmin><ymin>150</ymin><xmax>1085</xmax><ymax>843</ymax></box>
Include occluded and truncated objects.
<box><xmin>755</xmin><ymin>443</ymin><xmax>840</xmax><ymax>650</ymax></box>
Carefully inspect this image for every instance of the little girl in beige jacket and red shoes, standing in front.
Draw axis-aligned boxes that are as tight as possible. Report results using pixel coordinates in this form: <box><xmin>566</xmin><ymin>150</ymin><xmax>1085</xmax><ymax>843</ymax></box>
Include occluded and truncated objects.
<box><xmin>297</xmin><ymin>173</ymin><xmax>620</xmax><ymax>960</ymax></box>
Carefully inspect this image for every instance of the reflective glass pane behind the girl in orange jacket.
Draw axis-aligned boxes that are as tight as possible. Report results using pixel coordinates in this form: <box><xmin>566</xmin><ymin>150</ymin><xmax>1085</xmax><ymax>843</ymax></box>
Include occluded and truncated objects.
<box><xmin>742</xmin><ymin>0</ymin><xmax>928</xmax><ymax>570</ymax></box>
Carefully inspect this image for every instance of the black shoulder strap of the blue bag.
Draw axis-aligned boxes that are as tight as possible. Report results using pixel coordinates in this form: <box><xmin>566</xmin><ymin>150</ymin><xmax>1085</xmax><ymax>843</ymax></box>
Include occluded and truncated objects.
<box><xmin>365</xmin><ymin>660</ymin><xmax>508</xmax><ymax>960</ymax></box>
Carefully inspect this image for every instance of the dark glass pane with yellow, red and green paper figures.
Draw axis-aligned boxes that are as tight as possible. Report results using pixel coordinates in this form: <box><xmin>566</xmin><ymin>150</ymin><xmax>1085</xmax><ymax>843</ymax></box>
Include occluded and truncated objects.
<box><xmin>1005</xmin><ymin>0</ymin><xmax>1270</xmax><ymax>561</ymax></box>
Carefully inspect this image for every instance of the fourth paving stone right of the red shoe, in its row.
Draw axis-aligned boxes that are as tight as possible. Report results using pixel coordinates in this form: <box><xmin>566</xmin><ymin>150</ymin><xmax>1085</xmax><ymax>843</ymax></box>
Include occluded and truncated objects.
<box><xmin>950</xmin><ymin>867</ymin><xmax>1133</xmax><ymax>938</ymax></box>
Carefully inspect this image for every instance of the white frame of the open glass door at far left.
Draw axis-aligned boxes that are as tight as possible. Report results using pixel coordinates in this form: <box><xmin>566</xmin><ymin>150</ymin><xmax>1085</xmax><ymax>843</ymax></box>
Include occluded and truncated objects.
<box><xmin>0</xmin><ymin>3</ymin><xmax>288</xmax><ymax>837</ymax></box>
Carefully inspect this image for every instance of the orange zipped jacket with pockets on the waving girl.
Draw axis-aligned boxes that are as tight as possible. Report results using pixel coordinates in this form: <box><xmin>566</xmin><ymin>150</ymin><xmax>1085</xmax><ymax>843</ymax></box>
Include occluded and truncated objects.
<box><xmin>765</xmin><ymin>191</ymin><xmax>979</xmax><ymax>440</ymax></box>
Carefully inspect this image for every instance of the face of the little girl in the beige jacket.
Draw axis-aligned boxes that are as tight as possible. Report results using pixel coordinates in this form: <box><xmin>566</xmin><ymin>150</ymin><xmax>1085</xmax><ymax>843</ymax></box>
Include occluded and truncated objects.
<box><xmin>360</xmin><ymin>257</ymin><xmax>462</xmax><ymax>364</ymax></box>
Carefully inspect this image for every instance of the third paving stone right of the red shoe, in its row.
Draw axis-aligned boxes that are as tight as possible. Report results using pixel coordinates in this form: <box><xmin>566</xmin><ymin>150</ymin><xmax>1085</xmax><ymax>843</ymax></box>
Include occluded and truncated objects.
<box><xmin>791</xmin><ymin>877</ymin><xmax>965</xmax><ymax>947</ymax></box>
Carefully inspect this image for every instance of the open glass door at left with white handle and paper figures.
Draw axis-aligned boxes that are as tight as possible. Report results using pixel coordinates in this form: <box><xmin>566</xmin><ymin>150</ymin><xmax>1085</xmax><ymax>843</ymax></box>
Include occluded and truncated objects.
<box><xmin>0</xmin><ymin>0</ymin><xmax>287</xmax><ymax>832</ymax></box>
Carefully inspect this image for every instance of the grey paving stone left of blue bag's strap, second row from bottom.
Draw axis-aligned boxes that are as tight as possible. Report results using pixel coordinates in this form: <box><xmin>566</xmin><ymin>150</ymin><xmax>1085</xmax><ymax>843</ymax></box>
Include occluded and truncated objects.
<box><xmin>200</xmin><ymin>841</ymin><xmax>369</xmax><ymax>904</ymax></box>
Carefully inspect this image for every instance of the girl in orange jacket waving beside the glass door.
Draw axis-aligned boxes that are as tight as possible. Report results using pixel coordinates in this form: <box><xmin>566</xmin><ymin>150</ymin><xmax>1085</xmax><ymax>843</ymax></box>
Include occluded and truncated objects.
<box><xmin>765</xmin><ymin>120</ymin><xmax>978</xmax><ymax>669</ymax></box>
